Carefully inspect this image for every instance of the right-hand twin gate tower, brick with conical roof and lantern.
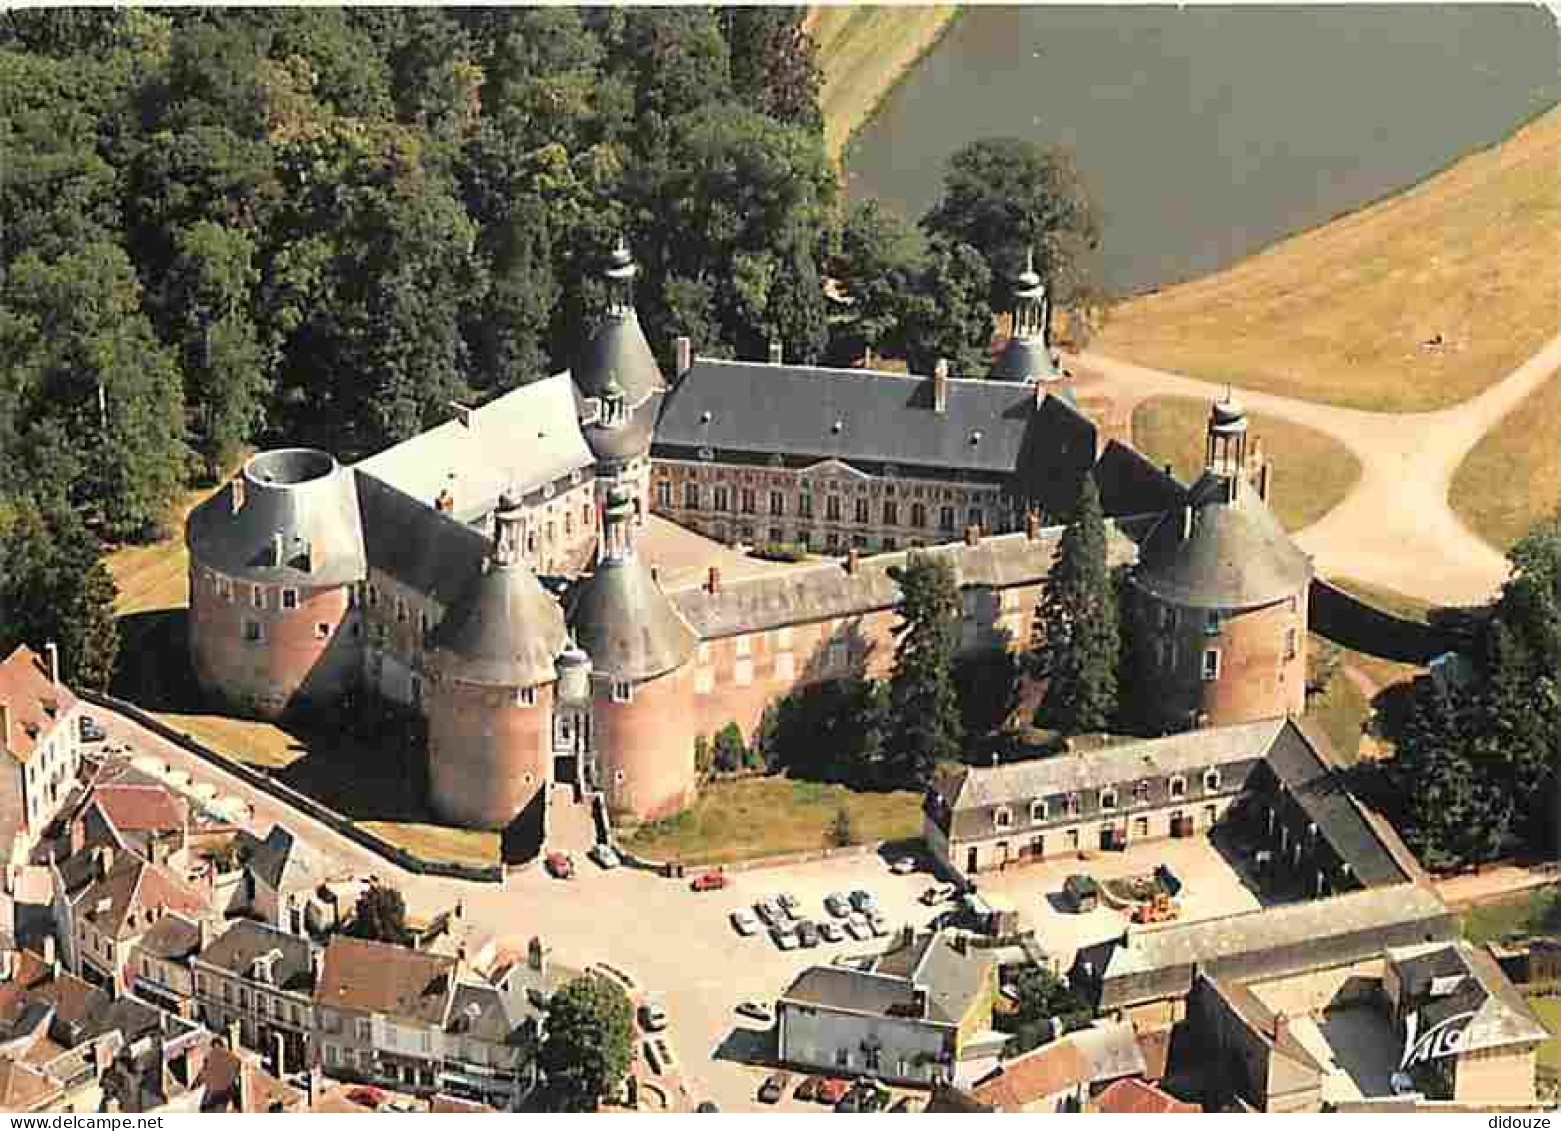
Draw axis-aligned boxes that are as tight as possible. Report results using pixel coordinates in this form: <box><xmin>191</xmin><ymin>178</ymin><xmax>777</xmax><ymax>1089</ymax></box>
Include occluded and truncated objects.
<box><xmin>570</xmin><ymin>485</ymin><xmax>699</xmax><ymax>819</ymax></box>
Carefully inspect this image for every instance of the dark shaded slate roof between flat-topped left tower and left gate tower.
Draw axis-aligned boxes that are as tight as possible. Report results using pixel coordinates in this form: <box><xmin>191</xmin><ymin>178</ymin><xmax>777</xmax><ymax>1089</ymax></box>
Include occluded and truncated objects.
<box><xmin>357</xmin><ymin>476</ymin><xmax>489</xmax><ymax>608</ymax></box>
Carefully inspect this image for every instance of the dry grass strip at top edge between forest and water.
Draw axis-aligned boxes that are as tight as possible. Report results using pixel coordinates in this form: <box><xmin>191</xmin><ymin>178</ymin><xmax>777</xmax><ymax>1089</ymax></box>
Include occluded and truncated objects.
<box><xmin>805</xmin><ymin>5</ymin><xmax>958</xmax><ymax>162</ymax></box>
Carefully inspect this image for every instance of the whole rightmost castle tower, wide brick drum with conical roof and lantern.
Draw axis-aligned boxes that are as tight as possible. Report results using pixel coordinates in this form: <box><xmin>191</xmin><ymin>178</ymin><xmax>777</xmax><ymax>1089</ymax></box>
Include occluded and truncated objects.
<box><xmin>1130</xmin><ymin>396</ymin><xmax>1313</xmax><ymax>730</ymax></box>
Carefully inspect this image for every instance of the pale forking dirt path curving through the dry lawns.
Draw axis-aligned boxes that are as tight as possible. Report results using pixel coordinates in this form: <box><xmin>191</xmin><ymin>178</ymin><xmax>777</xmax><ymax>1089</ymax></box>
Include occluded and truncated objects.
<box><xmin>1079</xmin><ymin>334</ymin><xmax>1561</xmax><ymax>605</ymax></box>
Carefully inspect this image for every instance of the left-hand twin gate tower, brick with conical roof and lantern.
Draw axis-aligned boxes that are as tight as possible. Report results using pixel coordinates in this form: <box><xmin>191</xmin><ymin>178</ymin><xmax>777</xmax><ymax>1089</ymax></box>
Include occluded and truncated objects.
<box><xmin>428</xmin><ymin>496</ymin><xmax>568</xmax><ymax>828</ymax></box>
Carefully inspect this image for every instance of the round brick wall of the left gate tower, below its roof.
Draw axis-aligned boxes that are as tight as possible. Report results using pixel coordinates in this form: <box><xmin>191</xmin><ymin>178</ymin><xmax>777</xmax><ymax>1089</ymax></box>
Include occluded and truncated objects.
<box><xmin>426</xmin><ymin>679</ymin><xmax>553</xmax><ymax>828</ymax></box>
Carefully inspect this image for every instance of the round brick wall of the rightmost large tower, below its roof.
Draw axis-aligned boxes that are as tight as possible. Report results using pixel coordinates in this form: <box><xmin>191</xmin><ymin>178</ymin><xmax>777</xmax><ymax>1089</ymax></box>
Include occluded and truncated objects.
<box><xmin>1136</xmin><ymin>588</ymin><xmax>1307</xmax><ymax>730</ymax></box>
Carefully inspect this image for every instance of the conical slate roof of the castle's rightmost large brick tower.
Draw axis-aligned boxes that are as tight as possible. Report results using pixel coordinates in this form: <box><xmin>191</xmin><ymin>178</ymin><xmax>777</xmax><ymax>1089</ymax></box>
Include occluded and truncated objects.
<box><xmin>1133</xmin><ymin>473</ymin><xmax>1313</xmax><ymax>608</ymax></box>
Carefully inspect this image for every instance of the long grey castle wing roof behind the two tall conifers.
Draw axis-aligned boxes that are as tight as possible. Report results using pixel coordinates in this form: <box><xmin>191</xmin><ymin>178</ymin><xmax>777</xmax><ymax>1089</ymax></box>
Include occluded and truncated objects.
<box><xmin>664</xmin><ymin>526</ymin><xmax>1136</xmax><ymax>639</ymax></box>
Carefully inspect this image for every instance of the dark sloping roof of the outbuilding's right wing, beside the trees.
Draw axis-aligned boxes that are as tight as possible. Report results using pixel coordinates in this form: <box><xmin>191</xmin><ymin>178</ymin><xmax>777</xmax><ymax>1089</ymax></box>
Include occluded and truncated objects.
<box><xmin>1266</xmin><ymin>725</ymin><xmax>1417</xmax><ymax>888</ymax></box>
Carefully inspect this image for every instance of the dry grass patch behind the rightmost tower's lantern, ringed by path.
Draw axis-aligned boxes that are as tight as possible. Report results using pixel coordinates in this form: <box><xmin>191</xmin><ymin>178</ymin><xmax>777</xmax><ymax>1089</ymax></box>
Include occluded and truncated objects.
<box><xmin>1133</xmin><ymin>396</ymin><xmax>1361</xmax><ymax>530</ymax></box>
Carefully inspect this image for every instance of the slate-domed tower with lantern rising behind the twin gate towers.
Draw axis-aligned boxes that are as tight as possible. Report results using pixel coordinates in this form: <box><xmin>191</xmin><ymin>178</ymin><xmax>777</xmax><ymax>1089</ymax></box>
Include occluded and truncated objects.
<box><xmin>573</xmin><ymin>239</ymin><xmax>667</xmax><ymax>515</ymax></box>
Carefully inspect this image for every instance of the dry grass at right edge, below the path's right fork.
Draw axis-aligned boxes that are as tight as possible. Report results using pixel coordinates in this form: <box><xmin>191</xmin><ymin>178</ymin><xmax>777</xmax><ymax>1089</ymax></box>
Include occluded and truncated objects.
<box><xmin>1447</xmin><ymin>368</ymin><xmax>1561</xmax><ymax>551</ymax></box>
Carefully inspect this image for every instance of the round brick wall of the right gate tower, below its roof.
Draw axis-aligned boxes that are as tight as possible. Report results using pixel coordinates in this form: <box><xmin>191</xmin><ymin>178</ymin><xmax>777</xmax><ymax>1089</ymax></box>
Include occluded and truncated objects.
<box><xmin>592</xmin><ymin>665</ymin><xmax>698</xmax><ymax>821</ymax></box>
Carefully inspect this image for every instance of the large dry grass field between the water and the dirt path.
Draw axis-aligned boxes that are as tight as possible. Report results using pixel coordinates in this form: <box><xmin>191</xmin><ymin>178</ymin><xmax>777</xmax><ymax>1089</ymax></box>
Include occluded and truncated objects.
<box><xmin>1096</xmin><ymin>109</ymin><xmax>1561</xmax><ymax>412</ymax></box>
